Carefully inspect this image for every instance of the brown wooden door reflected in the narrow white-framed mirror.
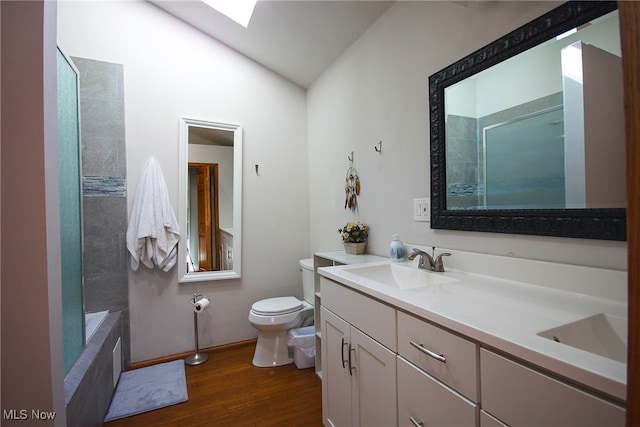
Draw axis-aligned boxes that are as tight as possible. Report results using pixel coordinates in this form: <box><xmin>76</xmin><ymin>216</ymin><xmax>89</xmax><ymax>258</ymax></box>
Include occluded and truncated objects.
<box><xmin>187</xmin><ymin>163</ymin><xmax>222</xmax><ymax>271</ymax></box>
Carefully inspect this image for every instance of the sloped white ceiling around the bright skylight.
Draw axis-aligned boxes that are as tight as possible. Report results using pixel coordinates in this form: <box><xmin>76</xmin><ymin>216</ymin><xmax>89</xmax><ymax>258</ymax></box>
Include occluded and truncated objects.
<box><xmin>148</xmin><ymin>0</ymin><xmax>394</xmax><ymax>88</ymax></box>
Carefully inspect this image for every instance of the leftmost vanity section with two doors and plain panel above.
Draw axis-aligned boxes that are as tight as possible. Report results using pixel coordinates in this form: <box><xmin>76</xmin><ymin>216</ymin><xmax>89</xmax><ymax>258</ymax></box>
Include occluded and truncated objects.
<box><xmin>321</xmin><ymin>278</ymin><xmax>397</xmax><ymax>427</ymax></box>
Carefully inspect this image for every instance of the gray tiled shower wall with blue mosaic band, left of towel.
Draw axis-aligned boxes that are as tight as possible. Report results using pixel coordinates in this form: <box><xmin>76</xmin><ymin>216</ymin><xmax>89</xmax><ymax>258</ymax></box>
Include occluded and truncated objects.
<box><xmin>72</xmin><ymin>57</ymin><xmax>131</xmax><ymax>367</ymax></box>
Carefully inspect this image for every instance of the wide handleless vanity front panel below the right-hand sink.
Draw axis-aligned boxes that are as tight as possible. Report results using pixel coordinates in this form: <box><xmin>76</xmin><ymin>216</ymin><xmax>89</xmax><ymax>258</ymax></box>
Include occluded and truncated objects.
<box><xmin>480</xmin><ymin>349</ymin><xmax>625</xmax><ymax>427</ymax></box>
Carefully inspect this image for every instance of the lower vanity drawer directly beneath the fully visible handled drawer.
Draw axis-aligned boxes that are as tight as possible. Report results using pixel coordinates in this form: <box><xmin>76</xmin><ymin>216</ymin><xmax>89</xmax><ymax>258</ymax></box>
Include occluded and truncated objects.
<box><xmin>397</xmin><ymin>357</ymin><xmax>477</xmax><ymax>427</ymax></box>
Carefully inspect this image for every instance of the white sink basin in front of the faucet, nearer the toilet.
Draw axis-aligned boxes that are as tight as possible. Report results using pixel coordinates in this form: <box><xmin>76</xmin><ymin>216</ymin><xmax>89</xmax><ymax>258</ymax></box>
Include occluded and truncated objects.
<box><xmin>348</xmin><ymin>264</ymin><xmax>457</xmax><ymax>289</ymax></box>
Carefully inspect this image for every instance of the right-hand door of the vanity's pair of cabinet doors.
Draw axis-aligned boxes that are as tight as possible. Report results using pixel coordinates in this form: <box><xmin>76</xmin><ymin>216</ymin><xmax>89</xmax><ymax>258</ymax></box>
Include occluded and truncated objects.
<box><xmin>351</xmin><ymin>327</ymin><xmax>397</xmax><ymax>427</ymax></box>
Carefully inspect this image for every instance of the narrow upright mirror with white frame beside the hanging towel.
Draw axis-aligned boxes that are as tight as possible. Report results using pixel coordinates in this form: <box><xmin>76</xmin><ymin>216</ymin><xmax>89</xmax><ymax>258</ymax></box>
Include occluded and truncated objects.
<box><xmin>178</xmin><ymin>117</ymin><xmax>242</xmax><ymax>283</ymax></box>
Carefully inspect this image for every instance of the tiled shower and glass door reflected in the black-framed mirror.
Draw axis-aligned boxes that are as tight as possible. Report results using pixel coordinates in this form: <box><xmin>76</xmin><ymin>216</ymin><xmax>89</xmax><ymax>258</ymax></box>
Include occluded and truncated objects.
<box><xmin>446</xmin><ymin>103</ymin><xmax>565</xmax><ymax>210</ymax></box>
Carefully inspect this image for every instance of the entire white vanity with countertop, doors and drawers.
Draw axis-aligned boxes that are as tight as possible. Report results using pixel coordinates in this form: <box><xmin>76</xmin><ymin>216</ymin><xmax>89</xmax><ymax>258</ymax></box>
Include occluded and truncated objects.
<box><xmin>318</xmin><ymin>248</ymin><xmax>626</xmax><ymax>427</ymax></box>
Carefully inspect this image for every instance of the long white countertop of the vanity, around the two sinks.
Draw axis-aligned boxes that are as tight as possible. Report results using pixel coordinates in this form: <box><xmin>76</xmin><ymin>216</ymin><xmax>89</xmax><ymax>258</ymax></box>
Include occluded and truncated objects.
<box><xmin>318</xmin><ymin>261</ymin><xmax>627</xmax><ymax>400</ymax></box>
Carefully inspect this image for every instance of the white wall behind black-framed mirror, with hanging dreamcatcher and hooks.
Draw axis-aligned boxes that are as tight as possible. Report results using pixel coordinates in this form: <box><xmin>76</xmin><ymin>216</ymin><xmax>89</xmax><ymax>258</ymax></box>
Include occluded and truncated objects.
<box><xmin>307</xmin><ymin>1</ymin><xmax>626</xmax><ymax>268</ymax></box>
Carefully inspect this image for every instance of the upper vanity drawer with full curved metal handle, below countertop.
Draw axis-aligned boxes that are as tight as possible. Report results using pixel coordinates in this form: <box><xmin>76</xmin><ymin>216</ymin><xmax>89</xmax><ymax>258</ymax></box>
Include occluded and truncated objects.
<box><xmin>398</xmin><ymin>312</ymin><xmax>478</xmax><ymax>402</ymax></box>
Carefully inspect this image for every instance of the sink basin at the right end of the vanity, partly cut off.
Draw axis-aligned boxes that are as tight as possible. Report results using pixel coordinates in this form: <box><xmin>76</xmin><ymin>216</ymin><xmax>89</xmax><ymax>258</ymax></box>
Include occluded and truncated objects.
<box><xmin>538</xmin><ymin>313</ymin><xmax>627</xmax><ymax>363</ymax></box>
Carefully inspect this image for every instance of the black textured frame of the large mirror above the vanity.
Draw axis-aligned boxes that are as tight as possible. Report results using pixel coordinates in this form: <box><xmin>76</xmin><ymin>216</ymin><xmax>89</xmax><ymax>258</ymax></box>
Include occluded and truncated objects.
<box><xmin>429</xmin><ymin>1</ymin><xmax>626</xmax><ymax>241</ymax></box>
